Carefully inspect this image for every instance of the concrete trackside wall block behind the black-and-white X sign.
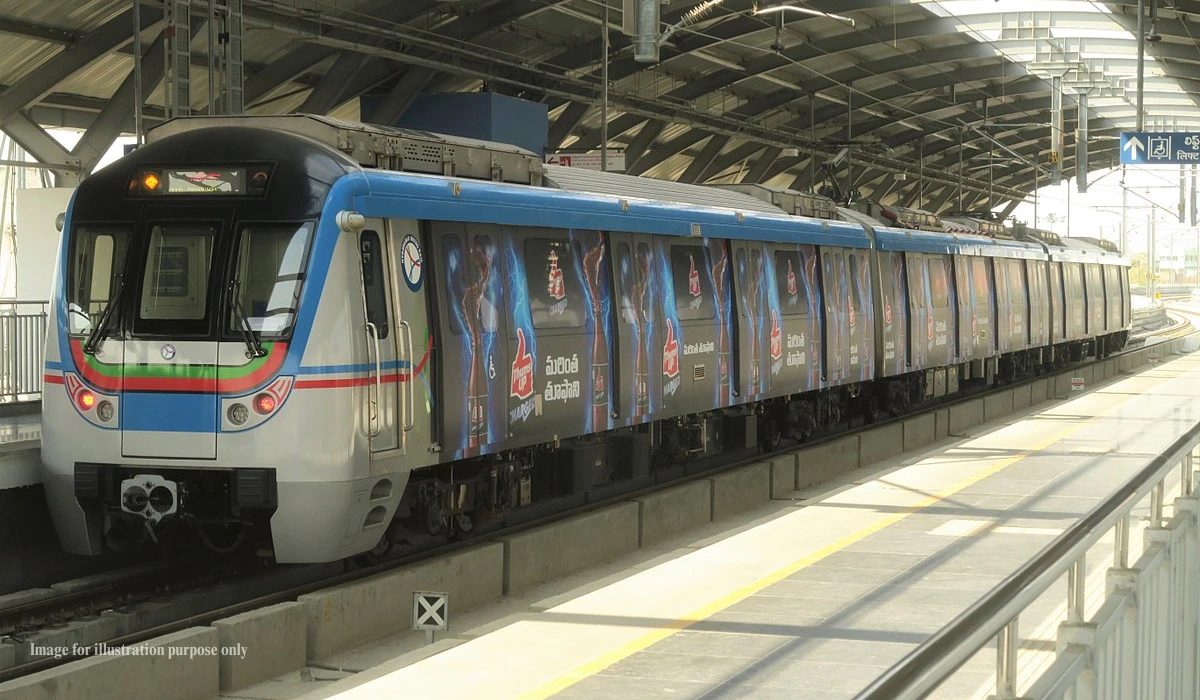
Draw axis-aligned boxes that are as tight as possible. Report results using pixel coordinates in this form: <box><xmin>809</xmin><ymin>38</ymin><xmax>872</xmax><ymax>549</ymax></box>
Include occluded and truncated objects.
<box><xmin>299</xmin><ymin>542</ymin><xmax>506</xmax><ymax>659</ymax></box>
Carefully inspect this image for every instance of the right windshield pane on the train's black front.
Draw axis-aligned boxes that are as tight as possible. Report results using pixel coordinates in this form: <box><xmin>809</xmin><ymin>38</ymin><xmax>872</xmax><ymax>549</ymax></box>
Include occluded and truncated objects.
<box><xmin>226</xmin><ymin>223</ymin><xmax>312</xmax><ymax>337</ymax></box>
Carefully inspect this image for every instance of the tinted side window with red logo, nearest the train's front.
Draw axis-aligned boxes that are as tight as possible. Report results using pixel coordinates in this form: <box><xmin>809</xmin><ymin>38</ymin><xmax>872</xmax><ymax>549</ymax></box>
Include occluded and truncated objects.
<box><xmin>524</xmin><ymin>238</ymin><xmax>588</xmax><ymax>328</ymax></box>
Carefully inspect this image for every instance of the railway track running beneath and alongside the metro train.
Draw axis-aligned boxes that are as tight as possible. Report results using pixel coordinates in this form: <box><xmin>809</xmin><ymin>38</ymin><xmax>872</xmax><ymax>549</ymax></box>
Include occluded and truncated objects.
<box><xmin>0</xmin><ymin>324</ymin><xmax>1200</xmax><ymax>682</ymax></box>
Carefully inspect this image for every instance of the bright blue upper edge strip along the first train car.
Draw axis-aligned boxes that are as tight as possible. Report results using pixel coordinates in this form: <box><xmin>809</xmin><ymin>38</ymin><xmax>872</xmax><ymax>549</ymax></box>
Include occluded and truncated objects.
<box><xmin>354</xmin><ymin>170</ymin><xmax>871</xmax><ymax>249</ymax></box>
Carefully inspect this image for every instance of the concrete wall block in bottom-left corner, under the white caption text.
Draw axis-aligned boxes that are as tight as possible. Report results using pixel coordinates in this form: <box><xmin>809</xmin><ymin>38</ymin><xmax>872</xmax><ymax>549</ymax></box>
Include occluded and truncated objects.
<box><xmin>0</xmin><ymin>627</ymin><xmax>220</xmax><ymax>700</ymax></box>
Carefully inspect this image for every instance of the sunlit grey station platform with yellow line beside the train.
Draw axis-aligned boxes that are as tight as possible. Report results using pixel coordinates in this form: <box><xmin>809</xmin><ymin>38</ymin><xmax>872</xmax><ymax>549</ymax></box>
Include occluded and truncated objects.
<box><xmin>304</xmin><ymin>353</ymin><xmax>1200</xmax><ymax>700</ymax></box>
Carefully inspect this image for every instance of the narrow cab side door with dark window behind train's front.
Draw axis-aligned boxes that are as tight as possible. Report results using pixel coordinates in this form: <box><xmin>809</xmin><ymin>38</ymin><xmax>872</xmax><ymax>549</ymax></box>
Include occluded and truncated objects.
<box><xmin>359</xmin><ymin>219</ymin><xmax>402</xmax><ymax>453</ymax></box>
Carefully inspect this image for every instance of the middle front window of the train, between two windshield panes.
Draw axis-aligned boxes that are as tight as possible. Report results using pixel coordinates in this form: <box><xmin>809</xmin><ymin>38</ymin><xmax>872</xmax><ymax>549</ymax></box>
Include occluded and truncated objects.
<box><xmin>138</xmin><ymin>223</ymin><xmax>218</xmax><ymax>330</ymax></box>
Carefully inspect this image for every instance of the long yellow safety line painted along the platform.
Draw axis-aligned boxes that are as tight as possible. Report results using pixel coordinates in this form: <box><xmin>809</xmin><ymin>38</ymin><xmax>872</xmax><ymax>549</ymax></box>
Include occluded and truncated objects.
<box><xmin>518</xmin><ymin>369</ymin><xmax>1177</xmax><ymax>700</ymax></box>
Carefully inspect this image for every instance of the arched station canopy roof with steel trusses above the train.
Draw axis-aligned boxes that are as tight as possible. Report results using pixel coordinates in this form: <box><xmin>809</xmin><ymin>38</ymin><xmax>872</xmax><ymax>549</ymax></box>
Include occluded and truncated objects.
<box><xmin>0</xmin><ymin>0</ymin><xmax>1200</xmax><ymax>213</ymax></box>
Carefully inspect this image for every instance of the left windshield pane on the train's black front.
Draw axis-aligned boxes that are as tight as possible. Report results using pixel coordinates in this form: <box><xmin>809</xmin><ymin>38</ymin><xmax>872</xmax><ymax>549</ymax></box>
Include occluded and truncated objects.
<box><xmin>67</xmin><ymin>228</ymin><xmax>128</xmax><ymax>334</ymax></box>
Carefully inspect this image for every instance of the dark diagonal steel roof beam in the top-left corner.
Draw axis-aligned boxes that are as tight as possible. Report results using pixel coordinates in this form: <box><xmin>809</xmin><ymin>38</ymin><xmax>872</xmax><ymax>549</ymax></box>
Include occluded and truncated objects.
<box><xmin>0</xmin><ymin>5</ymin><xmax>162</xmax><ymax>124</ymax></box>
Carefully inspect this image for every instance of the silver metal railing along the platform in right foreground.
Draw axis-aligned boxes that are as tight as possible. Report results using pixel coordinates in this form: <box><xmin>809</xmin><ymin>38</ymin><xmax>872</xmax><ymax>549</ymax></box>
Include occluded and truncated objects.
<box><xmin>857</xmin><ymin>405</ymin><xmax>1200</xmax><ymax>700</ymax></box>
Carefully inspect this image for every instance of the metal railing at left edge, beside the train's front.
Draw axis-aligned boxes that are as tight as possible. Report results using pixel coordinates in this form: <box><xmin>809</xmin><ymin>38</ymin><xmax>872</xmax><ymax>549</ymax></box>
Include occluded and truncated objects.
<box><xmin>0</xmin><ymin>299</ymin><xmax>49</xmax><ymax>403</ymax></box>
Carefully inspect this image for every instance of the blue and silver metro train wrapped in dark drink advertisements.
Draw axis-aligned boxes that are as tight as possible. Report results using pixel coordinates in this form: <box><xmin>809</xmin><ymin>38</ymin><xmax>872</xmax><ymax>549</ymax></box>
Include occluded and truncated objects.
<box><xmin>42</xmin><ymin>115</ymin><xmax>1132</xmax><ymax>562</ymax></box>
